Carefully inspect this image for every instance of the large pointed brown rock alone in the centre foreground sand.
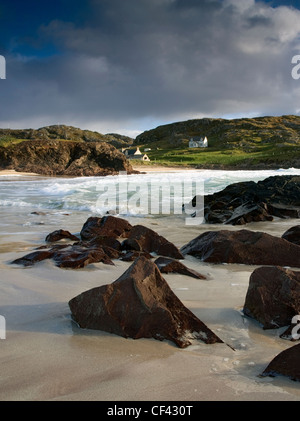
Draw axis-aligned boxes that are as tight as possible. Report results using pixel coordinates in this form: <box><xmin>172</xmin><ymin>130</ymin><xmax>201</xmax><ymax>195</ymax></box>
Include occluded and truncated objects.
<box><xmin>69</xmin><ymin>257</ymin><xmax>223</xmax><ymax>348</ymax></box>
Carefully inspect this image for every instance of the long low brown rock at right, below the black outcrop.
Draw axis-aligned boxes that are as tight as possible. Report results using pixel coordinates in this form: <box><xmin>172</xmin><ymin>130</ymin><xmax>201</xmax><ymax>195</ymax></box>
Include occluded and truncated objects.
<box><xmin>181</xmin><ymin>229</ymin><xmax>300</xmax><ymax>267</ymax></box>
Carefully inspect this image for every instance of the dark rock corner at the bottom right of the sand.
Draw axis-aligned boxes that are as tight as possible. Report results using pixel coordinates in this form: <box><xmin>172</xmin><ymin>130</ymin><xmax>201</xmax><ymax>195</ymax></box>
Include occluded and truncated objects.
<box><xmin>261</xmin><ymin>344</ymin><xmax>300</xmax><ymax>381</ymax></box>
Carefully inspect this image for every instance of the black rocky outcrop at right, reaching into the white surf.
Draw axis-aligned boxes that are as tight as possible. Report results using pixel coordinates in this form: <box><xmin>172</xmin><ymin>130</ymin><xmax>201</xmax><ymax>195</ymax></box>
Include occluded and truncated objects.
<box><xmin>188</xmin><ymin>176</ymin><xmax>300</xmax><ymax>225</ymax></box>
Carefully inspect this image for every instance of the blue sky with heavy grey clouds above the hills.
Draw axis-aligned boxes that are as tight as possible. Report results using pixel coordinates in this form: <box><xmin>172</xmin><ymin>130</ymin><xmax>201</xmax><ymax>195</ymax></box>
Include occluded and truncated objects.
<box><xmin>0</xmin><ymin>0</ymin><xmax>300</xmax><ymax>137</ymax></box>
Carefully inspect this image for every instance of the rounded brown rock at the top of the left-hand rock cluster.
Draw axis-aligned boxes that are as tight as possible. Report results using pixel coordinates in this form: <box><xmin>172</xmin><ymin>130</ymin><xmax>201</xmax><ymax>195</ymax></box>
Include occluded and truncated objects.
<box><xmin>80</xmin><ymin>215</ymin><xmax>132</xmax><ymax>241</ymax></box>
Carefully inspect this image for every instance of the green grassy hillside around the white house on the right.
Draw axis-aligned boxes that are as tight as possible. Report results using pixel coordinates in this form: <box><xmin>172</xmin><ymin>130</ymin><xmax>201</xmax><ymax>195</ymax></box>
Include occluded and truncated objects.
<box><xmin>135</xmin><ymin>116</ymin><xmax>300</xmax><ymax>169</ymax></box>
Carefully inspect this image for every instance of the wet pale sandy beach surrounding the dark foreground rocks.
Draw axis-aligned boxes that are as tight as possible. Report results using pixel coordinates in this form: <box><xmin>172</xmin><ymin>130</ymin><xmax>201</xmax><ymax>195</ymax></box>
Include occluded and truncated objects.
<box><xmin>0</xmin><ymin>168</ymin><xmax>300</xmax><ymax>402</ymax></box>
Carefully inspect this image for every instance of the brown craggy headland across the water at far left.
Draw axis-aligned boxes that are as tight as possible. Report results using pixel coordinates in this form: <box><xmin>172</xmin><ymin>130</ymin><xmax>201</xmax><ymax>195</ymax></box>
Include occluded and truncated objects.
<box><xmin>0</xmin><ymin>140</ymin><xmax>135</xmax><ymax>177</ymax></box>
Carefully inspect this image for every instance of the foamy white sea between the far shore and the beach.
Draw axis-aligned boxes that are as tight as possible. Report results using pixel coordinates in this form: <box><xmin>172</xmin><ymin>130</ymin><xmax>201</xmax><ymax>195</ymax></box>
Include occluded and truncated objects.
<box><xmin>0</xmin><ymin>168</ymin><xmax>300</xmax><ymax>225</ymax></box>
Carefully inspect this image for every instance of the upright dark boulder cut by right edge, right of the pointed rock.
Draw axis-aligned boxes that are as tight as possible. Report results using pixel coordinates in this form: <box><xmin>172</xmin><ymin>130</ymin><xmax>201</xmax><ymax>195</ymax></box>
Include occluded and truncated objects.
<box><xmin>243</xmin><ymin>266</ymin><xmax>300</xmax><ymax>329</ymax></box>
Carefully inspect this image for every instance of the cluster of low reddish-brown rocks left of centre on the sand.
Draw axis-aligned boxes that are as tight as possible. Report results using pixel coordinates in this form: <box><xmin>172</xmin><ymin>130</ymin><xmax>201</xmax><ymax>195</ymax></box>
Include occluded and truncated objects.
<box><xmin>12</xmin><ymin>215</ymin><xmax>186</xmax><ymax>273</ymax></box>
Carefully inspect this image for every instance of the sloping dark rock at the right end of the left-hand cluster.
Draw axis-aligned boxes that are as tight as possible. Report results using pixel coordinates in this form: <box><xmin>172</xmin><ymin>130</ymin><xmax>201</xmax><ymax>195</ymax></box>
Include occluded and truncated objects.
<box><xmin>127</xmin><ymin>225</ymin><xmax>183</xmax><ymax>259</ymax></box>
